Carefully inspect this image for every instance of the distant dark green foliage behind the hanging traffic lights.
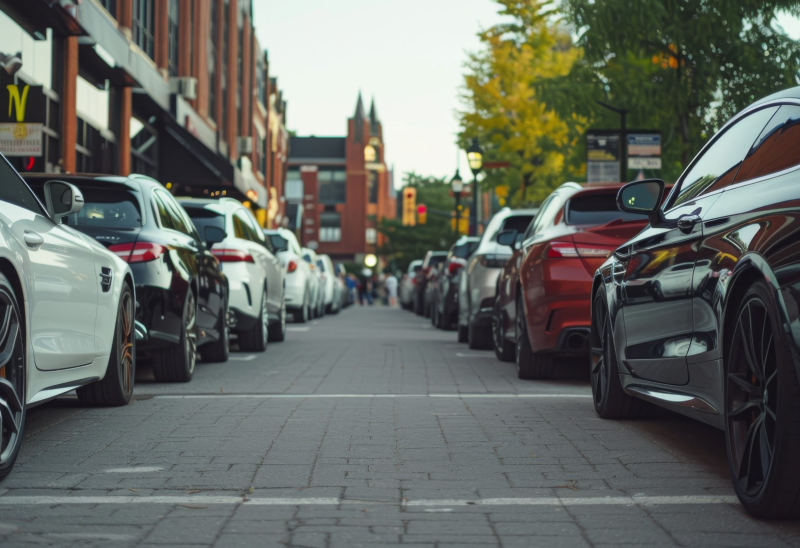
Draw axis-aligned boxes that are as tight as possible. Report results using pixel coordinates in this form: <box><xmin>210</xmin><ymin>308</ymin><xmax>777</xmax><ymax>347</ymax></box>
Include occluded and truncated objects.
<box><xmin>378</xmin><ymin>172</ymin><xmax>457</xmax><ymax>271</ymax></box>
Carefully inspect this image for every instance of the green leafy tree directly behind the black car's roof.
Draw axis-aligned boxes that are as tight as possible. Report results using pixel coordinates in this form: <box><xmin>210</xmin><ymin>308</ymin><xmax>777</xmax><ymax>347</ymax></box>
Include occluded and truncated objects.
<box><xmin>564</xmin><ymin>0</ymin><xmax>800</xmax><ymax>171</ymax></box>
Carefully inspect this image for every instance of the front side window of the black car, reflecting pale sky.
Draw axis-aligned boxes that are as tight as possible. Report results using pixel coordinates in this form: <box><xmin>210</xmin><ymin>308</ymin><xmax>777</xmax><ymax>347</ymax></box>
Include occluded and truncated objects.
<box><xmin>669</xmin><ymin>107</ymin><xmax>778</xmax><ymax>209</ymax></box>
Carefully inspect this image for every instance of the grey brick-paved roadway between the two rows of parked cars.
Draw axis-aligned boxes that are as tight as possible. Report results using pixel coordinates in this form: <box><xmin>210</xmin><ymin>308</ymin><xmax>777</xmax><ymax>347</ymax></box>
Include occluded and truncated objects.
<box><xmin>0</xmin><ymin>308</ymin><xmax>800</xmax><ymax>548</ymax></box>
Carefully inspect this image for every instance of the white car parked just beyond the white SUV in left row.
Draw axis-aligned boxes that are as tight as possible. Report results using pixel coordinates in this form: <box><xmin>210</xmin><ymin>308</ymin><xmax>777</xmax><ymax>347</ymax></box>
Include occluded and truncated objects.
<box><xmin>264</xmin><ymin>228</ymin><xmax>316</xmax><ymax>323</ymax></box>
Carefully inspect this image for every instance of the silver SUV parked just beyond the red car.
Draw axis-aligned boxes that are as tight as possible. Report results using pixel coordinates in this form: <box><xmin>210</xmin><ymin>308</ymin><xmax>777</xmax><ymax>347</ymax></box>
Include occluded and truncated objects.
<box><xmin>458</xmin><ymin>207</ymin><xmax>538</xmax><ymax>349</ymax></box>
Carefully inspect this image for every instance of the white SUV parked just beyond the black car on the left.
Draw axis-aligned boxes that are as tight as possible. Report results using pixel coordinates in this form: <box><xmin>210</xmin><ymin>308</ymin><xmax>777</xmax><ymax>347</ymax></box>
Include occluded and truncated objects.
<box><xmin>178</xmin><ymin>198</ymin><xmax>286</xmax><ymax>352</ymax></box>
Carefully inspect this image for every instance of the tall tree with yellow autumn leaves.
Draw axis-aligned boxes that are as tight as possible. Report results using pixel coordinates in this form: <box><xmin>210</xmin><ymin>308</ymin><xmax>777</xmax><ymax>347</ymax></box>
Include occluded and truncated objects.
<box><xmin>459</xmin><ymin>0</ymin><xmax>586</xmax><ymax>205</ymax></box>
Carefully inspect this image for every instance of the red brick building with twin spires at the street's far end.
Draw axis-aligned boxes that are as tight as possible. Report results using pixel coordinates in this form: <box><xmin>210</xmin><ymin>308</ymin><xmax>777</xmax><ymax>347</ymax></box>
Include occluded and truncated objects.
<box><xmin>284</xmin><ymin>94</ymin><xmax>397</xmax><ymax>263</ymax></box>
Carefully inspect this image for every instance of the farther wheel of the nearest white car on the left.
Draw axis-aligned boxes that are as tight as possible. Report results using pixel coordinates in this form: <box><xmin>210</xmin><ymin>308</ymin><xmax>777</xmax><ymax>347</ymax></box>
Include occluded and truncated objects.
<box><xmin>76</xmin><ymin>284</ymin><xmax>136</xmax><ymax>406</ymax></box>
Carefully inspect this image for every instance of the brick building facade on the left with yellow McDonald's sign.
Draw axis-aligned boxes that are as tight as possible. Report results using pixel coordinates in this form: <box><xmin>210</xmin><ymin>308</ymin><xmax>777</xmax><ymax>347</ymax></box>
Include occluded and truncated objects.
<box><xmin>0</xmin><ymin>0</ymin><xmax>288</xmax><ymax>226</ymax></box>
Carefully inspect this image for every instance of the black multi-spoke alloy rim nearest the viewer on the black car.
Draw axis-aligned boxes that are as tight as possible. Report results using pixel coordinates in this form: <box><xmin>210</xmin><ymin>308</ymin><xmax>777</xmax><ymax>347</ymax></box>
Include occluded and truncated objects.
<box><xmin>726</xmin><ymin>296</ymin><xmax>778</xmax><ymax>495</ymax></box>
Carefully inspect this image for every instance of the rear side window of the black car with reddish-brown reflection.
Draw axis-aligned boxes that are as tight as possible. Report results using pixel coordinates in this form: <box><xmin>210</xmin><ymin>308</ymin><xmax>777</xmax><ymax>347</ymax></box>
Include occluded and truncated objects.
<box><xmin>734</xmin><ymin>105</ymin><xmax>800</xmax><ymax>184</ymax></box>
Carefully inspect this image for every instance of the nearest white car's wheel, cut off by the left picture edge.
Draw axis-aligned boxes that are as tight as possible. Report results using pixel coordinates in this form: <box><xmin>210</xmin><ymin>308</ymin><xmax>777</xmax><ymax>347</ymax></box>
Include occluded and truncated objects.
<box><xmin>0</xmin><ymin>274</ymin><xmax>28</xmax><ymax>479</ymax></box>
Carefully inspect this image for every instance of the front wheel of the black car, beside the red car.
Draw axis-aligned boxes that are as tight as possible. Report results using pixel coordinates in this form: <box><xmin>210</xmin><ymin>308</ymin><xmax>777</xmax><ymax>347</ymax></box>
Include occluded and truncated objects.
<box><xmin>589</xmin><ymin>287</ymin><xmax>651</xmax><ymax>419</ymax></box>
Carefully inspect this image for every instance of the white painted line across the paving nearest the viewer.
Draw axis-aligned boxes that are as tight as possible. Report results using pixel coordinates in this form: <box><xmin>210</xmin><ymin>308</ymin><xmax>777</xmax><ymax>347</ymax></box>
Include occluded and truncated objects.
<box><xmin>0</xmin><ymin>495</ymin><xmax>738</xmax><ymax>512</ymax></box>
